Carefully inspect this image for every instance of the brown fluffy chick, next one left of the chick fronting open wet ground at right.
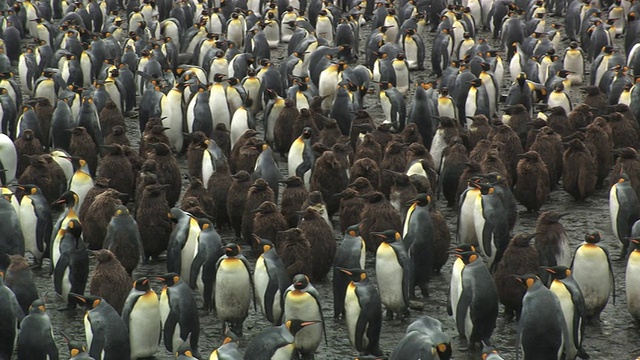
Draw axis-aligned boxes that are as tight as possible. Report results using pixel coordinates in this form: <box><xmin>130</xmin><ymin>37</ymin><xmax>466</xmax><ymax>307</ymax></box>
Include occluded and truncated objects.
<box><xmin>514</xmin><ymin>151</ymin><xmax>551</xmax><ymax>212</ymax></box>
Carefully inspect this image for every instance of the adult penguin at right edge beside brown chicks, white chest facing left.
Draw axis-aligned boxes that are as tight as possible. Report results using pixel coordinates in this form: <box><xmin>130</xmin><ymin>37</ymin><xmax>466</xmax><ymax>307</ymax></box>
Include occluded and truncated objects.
<box><xmin>609</xmin><ymin>173</ymin><xmax>640</xmax><ymax>259</ymax></box>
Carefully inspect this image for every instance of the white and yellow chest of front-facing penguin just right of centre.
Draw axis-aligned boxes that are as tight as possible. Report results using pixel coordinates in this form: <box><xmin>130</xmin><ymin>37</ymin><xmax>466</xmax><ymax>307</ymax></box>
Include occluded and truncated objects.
<box><xmin>376</xmin><ymin>243</ymin><xmax>405</xmax><ymax>313</ymax></box>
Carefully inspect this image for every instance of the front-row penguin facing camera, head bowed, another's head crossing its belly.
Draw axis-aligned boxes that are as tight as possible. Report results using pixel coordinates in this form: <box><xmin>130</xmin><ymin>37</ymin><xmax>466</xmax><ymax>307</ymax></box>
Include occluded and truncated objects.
<box><xmin>282</xmin><ymin>274</ymin><xmax>326</xmax><ymax>359</ymax></box>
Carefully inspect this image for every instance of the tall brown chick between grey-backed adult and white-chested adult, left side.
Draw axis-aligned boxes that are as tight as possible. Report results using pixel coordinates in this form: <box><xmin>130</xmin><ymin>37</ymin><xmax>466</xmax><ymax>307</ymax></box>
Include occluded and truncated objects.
<box><xmin>136</xmin><ymin>184</ymin><xmax>172</xmax><ymax>259</ymax></box>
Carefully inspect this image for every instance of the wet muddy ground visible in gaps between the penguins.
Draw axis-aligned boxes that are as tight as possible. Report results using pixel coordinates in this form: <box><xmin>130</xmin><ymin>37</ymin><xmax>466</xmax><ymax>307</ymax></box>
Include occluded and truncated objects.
<box><xmin>16</xmin><ymin>5</ymin><xmax>640</xmax><ymax>359</ymax></box>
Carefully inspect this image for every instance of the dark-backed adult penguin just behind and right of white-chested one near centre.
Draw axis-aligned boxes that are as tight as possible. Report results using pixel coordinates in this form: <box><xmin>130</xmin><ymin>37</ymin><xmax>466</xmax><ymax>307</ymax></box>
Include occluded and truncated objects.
<box><xmin>402</xmin><ymin>194</ymin><xmax>435</xmax><ymax>298</ymax></box>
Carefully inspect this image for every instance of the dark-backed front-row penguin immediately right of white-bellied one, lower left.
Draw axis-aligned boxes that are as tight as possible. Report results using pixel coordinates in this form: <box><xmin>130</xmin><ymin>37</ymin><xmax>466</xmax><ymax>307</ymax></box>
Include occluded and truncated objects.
<box><xmin>156</xmin><ymin>273</ymin><xmax>200</xmax><ymax>356</ymax></box>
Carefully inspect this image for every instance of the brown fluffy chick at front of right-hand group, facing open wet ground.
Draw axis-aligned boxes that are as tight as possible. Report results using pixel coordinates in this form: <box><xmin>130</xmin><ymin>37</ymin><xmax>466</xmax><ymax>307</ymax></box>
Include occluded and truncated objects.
<box><xmin>562</xmin><ymin>139</ymin><xmax>598</xmax><ymax>200</ymax></box>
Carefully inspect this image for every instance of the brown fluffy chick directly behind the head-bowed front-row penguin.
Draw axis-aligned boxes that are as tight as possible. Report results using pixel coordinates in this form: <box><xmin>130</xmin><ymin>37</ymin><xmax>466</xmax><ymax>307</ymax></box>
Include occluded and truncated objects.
<box><xmin>276</xmin><ymin>228</ymin><xmax>313</xmax><ymax>279</ymax></box>
